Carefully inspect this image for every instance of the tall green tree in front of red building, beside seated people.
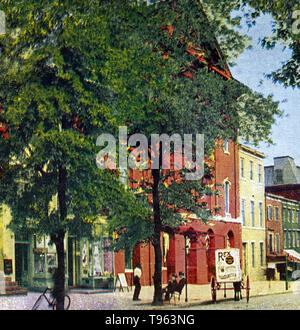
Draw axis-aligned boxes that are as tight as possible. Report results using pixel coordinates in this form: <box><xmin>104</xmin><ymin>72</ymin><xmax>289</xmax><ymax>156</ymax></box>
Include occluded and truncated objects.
<box><xmin>106</xmin><ymin>0</ymin><xmax>280</xmax><ymax>304</ymax></box>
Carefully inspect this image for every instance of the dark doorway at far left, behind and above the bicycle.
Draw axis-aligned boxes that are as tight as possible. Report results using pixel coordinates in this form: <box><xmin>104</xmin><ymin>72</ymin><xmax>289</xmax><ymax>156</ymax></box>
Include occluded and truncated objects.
<box><xmin>15</xmin><ymin>243</ymin><xmax>28</xmax><ymax>286</ymax></box>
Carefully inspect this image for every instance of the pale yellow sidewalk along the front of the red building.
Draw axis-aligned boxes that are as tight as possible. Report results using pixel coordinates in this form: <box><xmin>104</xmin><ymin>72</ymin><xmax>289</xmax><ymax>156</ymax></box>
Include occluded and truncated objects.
<box><xmin>115</xmin><ymin>281</ymin><xmax>300</xmax><ymax>310</ymax></box>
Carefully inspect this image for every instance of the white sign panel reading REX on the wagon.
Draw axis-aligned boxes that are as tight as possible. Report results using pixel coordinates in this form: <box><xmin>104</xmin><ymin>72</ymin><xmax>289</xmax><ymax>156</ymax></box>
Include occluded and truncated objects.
<box><xmin>215</xmin><ymin>248</ymin><xmax>242</xmax><ymax>282</ymax></box>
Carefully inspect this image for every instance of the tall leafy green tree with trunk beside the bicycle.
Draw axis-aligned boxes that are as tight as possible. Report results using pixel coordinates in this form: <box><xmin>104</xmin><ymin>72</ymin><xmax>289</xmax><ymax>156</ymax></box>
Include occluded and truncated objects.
<box><xmin>0</xmin><ymin>0</ymin><xmax>138</xmax><ymax>309</ymax></box>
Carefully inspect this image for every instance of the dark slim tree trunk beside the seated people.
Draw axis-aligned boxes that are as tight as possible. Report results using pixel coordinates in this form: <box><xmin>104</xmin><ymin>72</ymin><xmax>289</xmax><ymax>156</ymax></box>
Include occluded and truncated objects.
<box><xmin>152</xmin><ymin>169</ymin><xmax>163</xmax><ymax>306</ymax></box>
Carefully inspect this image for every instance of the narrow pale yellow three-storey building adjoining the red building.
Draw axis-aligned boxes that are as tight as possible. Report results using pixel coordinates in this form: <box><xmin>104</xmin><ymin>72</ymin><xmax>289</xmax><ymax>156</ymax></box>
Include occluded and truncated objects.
<box><xmin>239</xmin><ymin>145</ymin><xmax>266</xmax><ymax>281</ymax></box>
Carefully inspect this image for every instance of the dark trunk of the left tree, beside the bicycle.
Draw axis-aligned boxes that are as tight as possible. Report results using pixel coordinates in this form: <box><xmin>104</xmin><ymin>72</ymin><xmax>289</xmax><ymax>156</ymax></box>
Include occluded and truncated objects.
<box><xmin>51</xmin><ymin>166</ymin><xmax>67</xmax><ymax>310</ymax></box>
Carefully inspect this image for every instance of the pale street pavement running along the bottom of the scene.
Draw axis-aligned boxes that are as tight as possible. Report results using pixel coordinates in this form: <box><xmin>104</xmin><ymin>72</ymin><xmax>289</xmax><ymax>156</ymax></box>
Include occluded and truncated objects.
<box><xmin>0</xmin><ymin>292</ymin><xmax>300</xmax><ymax>310</ymax></box>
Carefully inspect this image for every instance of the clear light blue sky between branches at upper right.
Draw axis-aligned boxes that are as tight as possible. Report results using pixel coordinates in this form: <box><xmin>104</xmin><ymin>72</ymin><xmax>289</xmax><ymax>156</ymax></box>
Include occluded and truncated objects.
<box><xmin>230</xmin><ymin>15</ymin><xmax>300</xmax><ymax>166</ymax></box>
